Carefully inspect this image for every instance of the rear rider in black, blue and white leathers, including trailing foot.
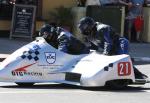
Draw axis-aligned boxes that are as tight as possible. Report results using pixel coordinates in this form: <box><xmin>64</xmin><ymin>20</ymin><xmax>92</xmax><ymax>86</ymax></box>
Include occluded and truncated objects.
<box><xmin>78</xmin><ymin>17</ymin><xmax>147</xmax><ymax>79</ymax></box>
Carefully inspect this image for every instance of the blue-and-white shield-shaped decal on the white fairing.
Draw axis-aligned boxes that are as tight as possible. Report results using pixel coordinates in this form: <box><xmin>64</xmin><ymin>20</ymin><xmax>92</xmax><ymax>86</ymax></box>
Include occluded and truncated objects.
<box><xmin>45</xmin><ymin>52</ymin><xmax>56</xmax><ymax>64</ymax></box>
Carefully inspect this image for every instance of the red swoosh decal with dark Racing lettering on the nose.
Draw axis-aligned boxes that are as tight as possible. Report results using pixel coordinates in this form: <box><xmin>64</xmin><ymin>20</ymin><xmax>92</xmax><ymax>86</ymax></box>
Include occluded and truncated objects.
<box><xmin>11</xmin><ymin>63</ymin><xmax>42</xmax><ymax>76</ymax></box>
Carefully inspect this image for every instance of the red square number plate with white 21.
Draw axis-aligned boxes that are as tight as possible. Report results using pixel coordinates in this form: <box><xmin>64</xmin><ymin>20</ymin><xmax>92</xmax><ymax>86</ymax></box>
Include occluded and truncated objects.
<box><xmin>118</xmin><ymin>62</ymin><xmax>131</xmax><ymax>76</ymax></box>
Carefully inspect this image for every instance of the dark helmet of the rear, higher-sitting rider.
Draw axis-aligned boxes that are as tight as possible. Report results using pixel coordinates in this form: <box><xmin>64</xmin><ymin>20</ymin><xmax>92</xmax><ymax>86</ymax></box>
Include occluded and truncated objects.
<box><xmin>78</xmin><ymin>17</ymin><xmax>95</xmax><ymax>35</ymax></box>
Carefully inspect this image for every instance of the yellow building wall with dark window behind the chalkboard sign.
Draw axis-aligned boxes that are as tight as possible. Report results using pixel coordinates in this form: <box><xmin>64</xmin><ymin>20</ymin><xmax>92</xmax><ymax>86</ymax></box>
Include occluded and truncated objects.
<box><xmin>0</xmin><ymin>0</ymin><xmax>77</xmax><ymax>37</ymax></box>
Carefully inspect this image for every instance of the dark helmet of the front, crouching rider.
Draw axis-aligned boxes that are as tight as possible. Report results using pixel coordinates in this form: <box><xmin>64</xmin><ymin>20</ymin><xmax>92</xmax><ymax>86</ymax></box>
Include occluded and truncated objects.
<box><xmin>39</xmin><ymin>24</ymin><xmax>56</xmax><ymax>39</ymax></box>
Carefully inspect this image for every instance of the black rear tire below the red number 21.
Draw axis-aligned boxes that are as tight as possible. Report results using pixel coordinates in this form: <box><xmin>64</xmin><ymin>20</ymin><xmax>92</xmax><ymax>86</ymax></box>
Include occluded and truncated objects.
<box><xmin>105</xmin><ymin>79</ymin><xmax>132</xmax><ymax>89</ymax></box>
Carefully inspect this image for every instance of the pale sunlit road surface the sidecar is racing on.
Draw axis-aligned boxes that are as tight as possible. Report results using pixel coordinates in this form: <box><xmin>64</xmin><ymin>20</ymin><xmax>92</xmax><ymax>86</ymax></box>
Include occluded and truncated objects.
<box><xmin>0</xmin><ymin>63</ymin><xmax>150</xmax><ymax>103</ymax></box>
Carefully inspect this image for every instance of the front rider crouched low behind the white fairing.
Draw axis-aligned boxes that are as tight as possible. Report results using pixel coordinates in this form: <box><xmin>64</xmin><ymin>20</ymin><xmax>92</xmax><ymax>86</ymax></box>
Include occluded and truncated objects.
<box><xmin>39</xmin><ymin>24</ymin><xmax>89</xmax><ymax>54</ymax></box>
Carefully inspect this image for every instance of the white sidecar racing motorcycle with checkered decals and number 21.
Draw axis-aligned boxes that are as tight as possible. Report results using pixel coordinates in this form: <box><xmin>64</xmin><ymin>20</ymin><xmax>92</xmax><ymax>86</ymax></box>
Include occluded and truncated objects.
<box><xmin>0</xmin><ymin>37</ymin><xmax>148</xmax><ymax>88</ymax></box>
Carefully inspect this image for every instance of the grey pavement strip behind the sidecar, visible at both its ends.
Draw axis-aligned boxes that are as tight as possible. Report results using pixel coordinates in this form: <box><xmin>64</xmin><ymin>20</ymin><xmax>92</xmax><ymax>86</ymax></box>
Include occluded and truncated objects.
<box><xmin>0</xmin><ymin>37</ymin><xmax>150</xmax><ymax>63</ymax></box>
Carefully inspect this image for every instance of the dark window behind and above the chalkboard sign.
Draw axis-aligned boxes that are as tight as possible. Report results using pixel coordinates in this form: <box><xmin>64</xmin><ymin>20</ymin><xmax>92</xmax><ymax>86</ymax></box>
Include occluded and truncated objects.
<box><xmin>0</xmin><ymin>0</ymin><xmax>42</xmax><ymax>19</ymax></box>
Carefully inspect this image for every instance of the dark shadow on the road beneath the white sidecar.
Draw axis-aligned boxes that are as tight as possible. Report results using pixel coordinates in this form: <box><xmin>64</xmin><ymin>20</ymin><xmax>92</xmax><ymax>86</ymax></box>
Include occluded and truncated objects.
<box><xmin>0</xmin><ymin>84</ymin><xmax>150</xmax><ymax>93</ymax></box>
